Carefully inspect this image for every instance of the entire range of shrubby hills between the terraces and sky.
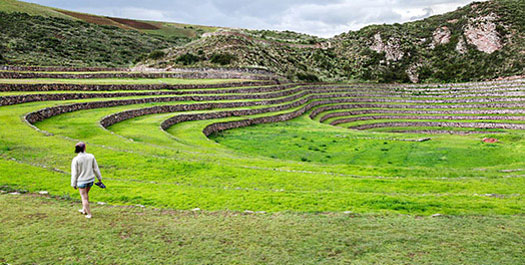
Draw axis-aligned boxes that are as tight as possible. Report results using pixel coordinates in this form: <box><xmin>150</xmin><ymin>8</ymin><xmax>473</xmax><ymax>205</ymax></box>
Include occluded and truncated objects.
<box><xmin>0</xmin><ymin>0</ymin><xmax>525</xmax><ymax>82</ymax></box>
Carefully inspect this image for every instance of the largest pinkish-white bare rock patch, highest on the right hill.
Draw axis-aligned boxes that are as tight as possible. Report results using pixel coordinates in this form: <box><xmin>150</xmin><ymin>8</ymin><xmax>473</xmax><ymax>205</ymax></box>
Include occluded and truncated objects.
<box><xmin>464</xmin><ymin>14</ymin><xmax>503</xmax><ymax>54</ymax></box>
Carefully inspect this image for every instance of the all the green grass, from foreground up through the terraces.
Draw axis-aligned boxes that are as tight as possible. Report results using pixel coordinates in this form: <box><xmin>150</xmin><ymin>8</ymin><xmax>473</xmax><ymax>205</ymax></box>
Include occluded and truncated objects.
<box><xmin>0</xmin><ymin>73</ymin><xmax>525</xmax><ymax>264</ymax></box>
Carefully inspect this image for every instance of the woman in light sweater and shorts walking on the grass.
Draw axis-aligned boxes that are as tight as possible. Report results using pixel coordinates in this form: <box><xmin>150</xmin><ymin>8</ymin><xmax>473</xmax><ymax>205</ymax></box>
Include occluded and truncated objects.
<box><xmin>71</xmin><ymin>142</ymin><xmax>102</xmax><ymax>218</ymax></box>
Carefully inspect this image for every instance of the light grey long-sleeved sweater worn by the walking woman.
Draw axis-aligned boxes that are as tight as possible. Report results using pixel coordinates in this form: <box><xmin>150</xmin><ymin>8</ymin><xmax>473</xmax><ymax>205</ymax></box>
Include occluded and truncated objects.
<box><xmin>71</xmin><ymin>153</ymin><xmax>102</xmax><ymax>187</ymax></box>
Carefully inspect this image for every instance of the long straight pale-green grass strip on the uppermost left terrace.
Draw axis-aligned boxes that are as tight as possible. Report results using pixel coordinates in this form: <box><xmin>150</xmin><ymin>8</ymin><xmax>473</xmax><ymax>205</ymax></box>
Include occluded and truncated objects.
<box><xmin>0</xmin><ymin>78</ymin><xmax>250</xmax><ymax>85</ymax></box>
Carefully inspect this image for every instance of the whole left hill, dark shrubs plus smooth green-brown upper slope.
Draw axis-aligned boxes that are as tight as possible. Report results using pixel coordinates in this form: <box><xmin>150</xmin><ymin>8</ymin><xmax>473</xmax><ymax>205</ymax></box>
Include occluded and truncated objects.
<box><xmin>0</xmin><ymin>0</ymin><xmax>216</xmax><ymax>67</ymax></box>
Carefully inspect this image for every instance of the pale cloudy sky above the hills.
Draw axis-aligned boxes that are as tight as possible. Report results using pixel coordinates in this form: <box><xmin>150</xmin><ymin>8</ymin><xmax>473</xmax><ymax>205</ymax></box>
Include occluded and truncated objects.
<box><xmin>25</xmin><ymin>0</ymin><xmax>484</xmax><ymax>37</ymax></box>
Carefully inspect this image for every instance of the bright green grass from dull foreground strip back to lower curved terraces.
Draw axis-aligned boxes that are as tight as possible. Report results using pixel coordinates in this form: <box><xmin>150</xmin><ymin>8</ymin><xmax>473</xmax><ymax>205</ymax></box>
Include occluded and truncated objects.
<box><xmin>0</xmin><ymin>86</ymin><xmax>524</xmax><ymax>212</ymax></box>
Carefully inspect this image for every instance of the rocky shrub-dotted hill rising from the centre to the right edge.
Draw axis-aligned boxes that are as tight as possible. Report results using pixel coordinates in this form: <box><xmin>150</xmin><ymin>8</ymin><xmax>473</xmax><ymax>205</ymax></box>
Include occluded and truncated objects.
<box><xmin>144</xmin><ymin>0</ymin><xmax>525</xmax><ymax>82</ymax></box>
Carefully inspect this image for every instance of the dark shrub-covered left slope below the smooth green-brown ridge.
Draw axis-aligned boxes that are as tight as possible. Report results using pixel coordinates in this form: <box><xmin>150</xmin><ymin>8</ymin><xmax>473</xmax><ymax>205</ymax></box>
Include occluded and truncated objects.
<box><xmin>0</xmin><ymin>12</ymin><xmax>182</xmax><ymax>67</ymax></box>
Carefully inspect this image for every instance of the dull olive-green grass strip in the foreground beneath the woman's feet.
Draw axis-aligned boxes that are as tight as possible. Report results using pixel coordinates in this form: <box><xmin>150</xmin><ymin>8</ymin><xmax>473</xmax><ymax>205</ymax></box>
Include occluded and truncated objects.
<box><xmin>0</xmin><ymin>190</ymin><xmax>525</xmax><ymax>264</ymax></box>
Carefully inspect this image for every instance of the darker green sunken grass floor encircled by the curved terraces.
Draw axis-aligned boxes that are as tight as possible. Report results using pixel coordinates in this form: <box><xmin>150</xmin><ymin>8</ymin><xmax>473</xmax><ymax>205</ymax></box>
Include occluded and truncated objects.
<box><xmin>213</xmin><ymin>115</ymin><xmax>525</xmax><ymax>167</ymax></box>
